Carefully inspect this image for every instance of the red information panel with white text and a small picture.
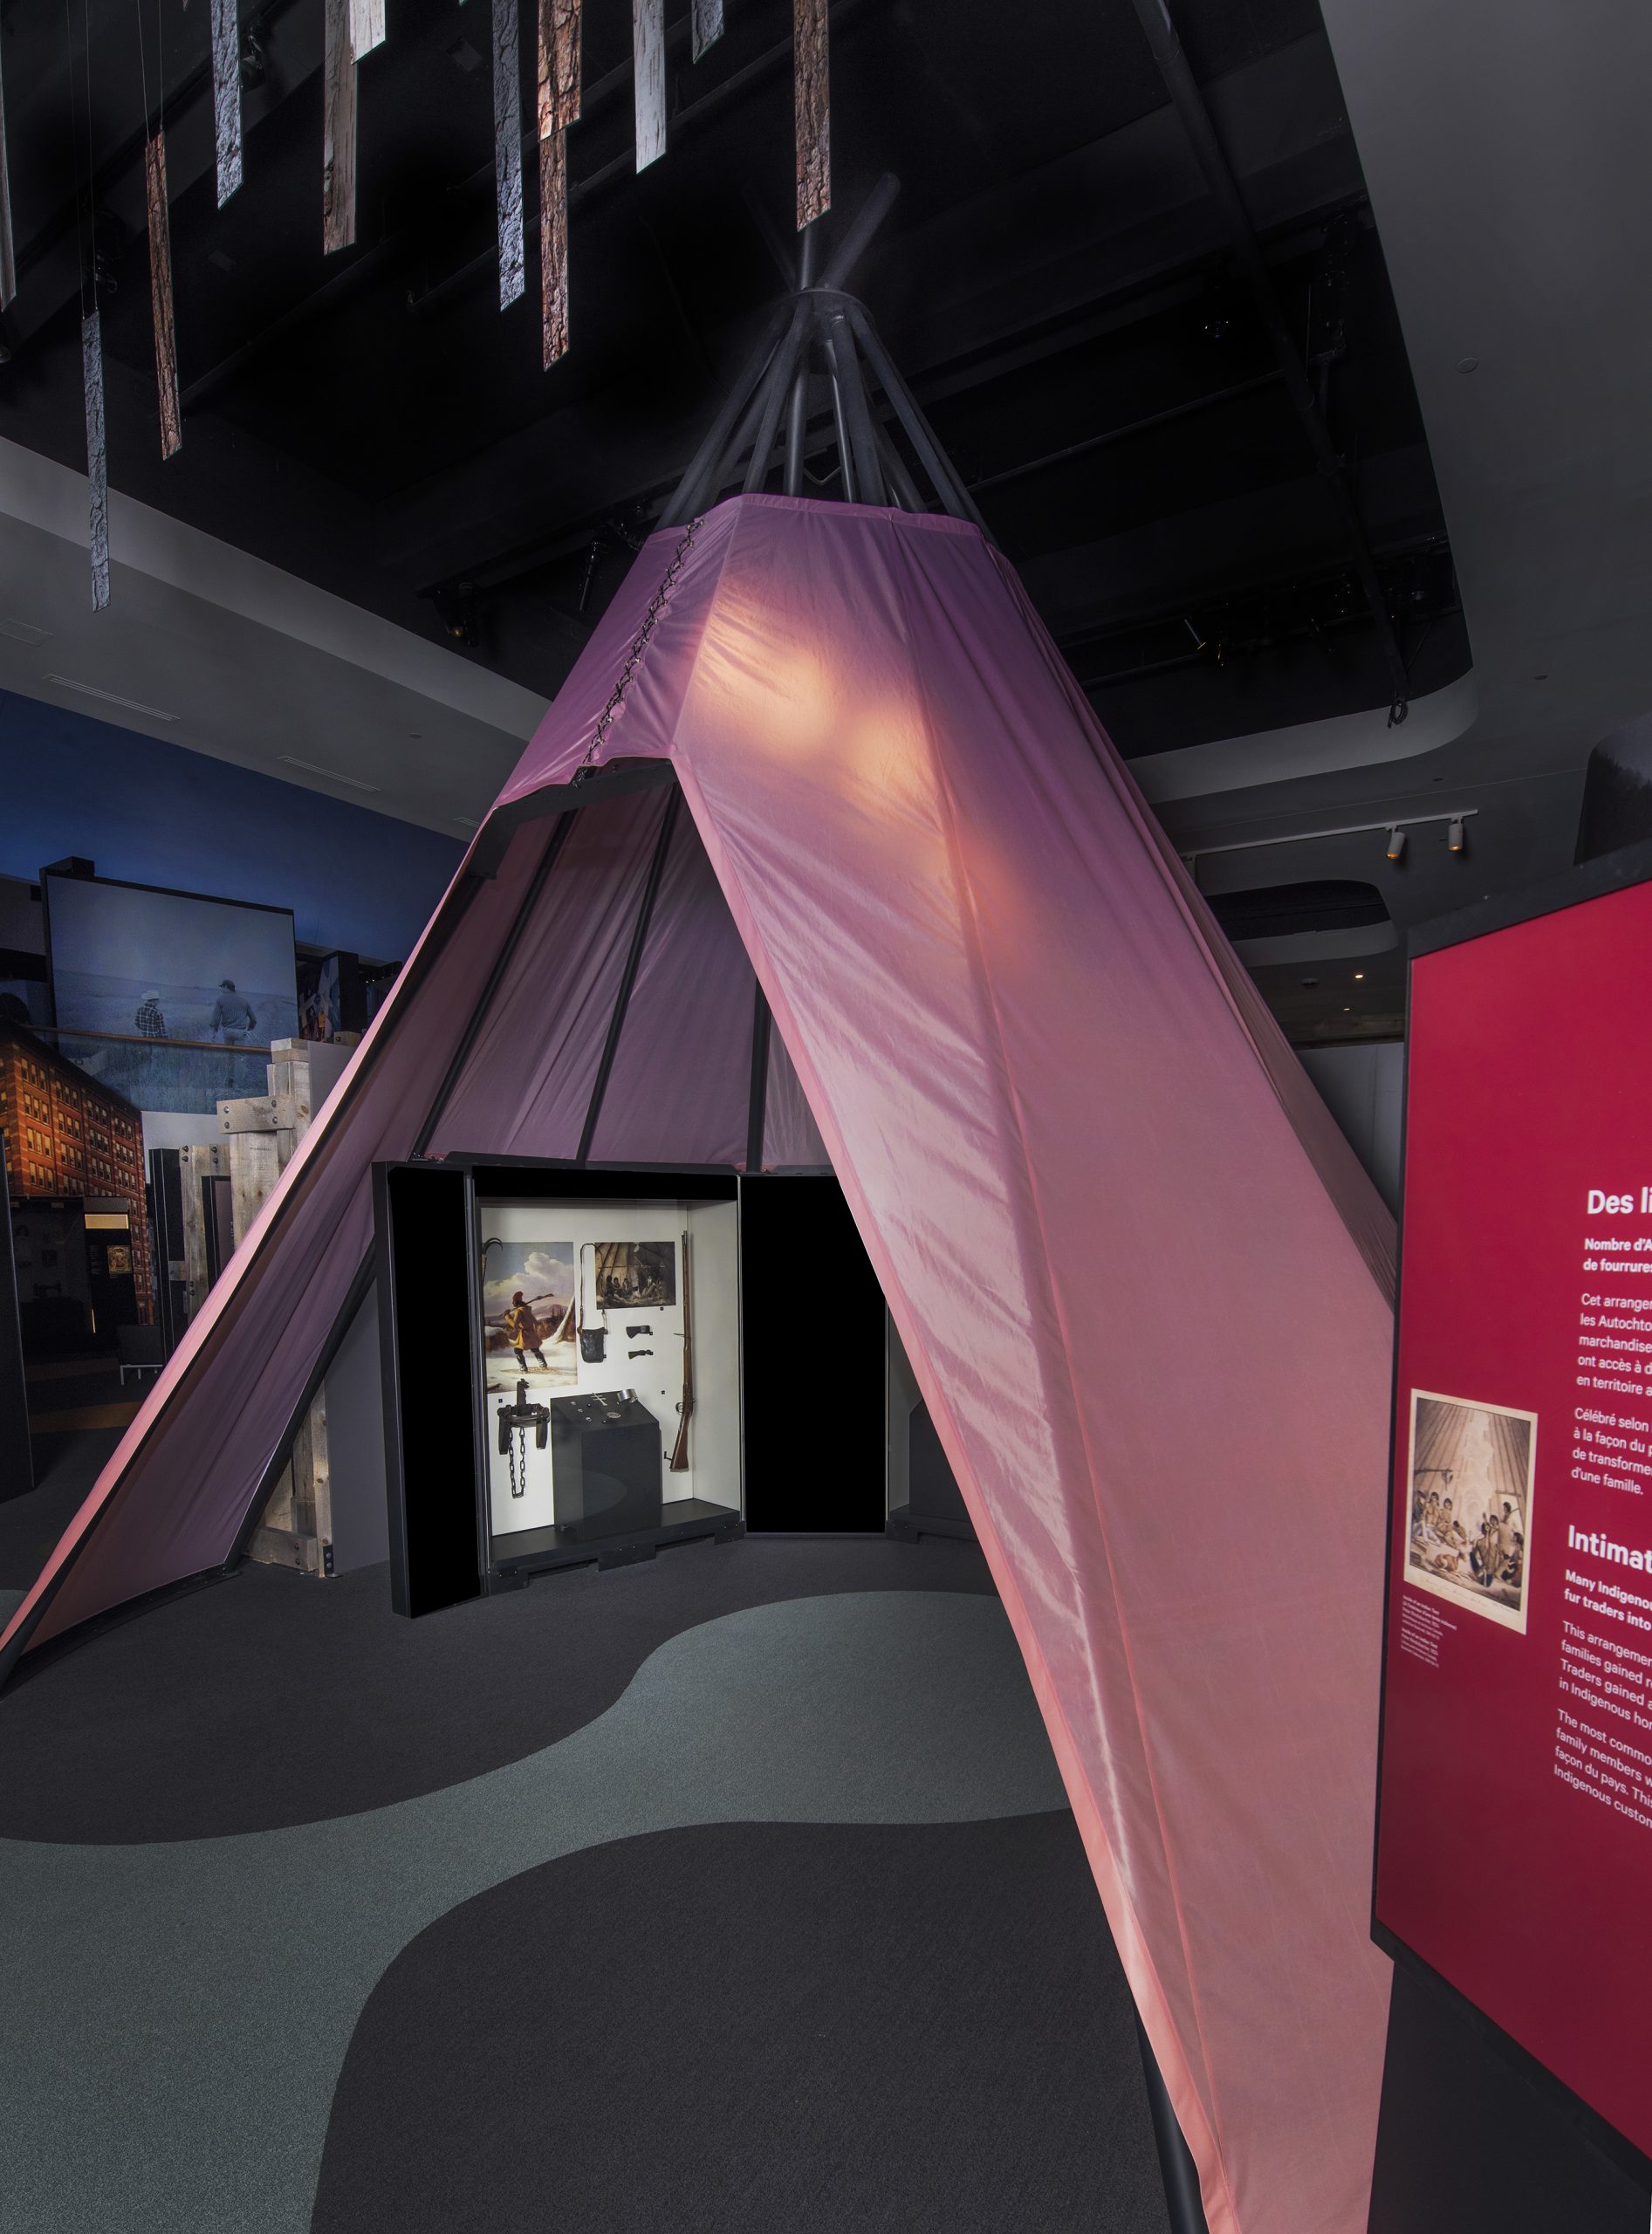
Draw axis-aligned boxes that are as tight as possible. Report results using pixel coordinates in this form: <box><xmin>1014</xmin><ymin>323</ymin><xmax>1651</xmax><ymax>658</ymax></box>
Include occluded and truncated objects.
<box><xmin>1374</xmin><ymin>862</ymin><xmax>1652</xmax><ymax>2154</ymax></box>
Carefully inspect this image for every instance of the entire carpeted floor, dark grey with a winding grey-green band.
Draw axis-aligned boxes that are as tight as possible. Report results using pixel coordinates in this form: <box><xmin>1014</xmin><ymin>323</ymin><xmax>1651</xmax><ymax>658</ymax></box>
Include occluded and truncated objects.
<box><xmin>0</xmin><ymin>1510</ymin><xmax>1165</xmax><ymax>2234</ymax></box>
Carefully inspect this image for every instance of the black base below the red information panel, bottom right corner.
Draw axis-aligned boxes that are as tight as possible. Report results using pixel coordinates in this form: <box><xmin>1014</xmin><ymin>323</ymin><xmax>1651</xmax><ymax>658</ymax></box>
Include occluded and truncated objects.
<box><xmin>1370</xmin><ymin>1962</ymin><xmax>1649</xmax><ymax>2234</ymax></box>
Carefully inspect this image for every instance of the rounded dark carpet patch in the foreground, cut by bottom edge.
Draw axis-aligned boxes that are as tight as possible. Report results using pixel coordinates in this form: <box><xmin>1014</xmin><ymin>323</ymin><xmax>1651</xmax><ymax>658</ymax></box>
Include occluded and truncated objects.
<box><xmin>313</xmin><ymin>1812</ymin><xmax>1167</xmax><ymax>2234</ymax></box>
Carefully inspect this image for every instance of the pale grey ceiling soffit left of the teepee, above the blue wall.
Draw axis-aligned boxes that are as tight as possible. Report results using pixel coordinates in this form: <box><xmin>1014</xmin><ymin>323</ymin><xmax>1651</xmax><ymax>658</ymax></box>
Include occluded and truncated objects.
<box><xmin>0</xmin><ymin>440</ymin><xmax>545</xmax><ymax>840</ymax></box>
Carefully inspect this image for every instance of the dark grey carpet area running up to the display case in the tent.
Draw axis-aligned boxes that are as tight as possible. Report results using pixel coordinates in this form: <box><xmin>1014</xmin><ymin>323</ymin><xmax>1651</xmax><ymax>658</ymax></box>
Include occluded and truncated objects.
<box><xmin>0</xmin><ymin>1528</ymin><xmax>992</xmax><ymax>1846</ymax></box>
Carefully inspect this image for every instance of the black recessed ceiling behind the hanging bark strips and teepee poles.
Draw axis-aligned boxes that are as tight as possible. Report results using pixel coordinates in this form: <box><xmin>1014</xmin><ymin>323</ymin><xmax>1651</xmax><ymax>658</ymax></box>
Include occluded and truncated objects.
<box><xmin>0</xmin><ymin>0</ymin><xmax>1469</xmax><ymax>772</ymax></box>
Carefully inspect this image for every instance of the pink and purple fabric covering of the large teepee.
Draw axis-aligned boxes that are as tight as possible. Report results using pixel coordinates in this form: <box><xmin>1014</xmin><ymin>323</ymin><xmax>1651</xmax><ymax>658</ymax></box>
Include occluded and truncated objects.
<box><xmin>0</xmin><ymin>496</ymin><xmax>1393</xmax><ymax>2234</ymax></box>
